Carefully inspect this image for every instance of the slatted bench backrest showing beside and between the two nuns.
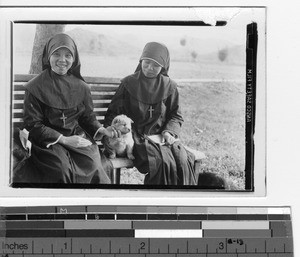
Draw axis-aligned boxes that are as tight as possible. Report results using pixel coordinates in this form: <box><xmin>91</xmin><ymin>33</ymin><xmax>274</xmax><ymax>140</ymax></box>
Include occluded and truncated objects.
<box><xmin>12</xmin><ymin>74</ymin><xmax>120</xmax><ymax>128</ymax></box>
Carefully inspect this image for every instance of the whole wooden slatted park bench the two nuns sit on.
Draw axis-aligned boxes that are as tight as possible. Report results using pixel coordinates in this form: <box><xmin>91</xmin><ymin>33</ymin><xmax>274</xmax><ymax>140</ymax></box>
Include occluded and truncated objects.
<box><xmin>12</xmin><ymin>74</ymin><xmax>205</xmax><ymax>184</ymax></box>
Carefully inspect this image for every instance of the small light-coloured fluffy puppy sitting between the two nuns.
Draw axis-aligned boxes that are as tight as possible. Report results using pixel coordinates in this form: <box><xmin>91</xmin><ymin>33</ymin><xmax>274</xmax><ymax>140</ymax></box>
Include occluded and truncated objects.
<box><xmin>103</xmin><ymin>114</ymin><xmax>134</xmax><ymax>160</ymax></box>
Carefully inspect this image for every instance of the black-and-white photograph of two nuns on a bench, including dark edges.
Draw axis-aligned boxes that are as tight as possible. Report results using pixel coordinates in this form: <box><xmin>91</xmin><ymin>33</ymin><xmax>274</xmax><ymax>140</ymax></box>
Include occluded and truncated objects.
<box><xmin>9</xmin><ymin>8</ymin><xmax>265</xmax><ymax>192</ymax></box>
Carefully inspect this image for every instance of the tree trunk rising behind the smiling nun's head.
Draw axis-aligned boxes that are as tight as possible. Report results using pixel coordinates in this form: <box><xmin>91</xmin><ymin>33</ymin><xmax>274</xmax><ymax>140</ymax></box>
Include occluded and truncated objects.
<box><xmin>29</xmin><ymin>24</ymin><xmax>66</xmax><ymax>74</ymax></box>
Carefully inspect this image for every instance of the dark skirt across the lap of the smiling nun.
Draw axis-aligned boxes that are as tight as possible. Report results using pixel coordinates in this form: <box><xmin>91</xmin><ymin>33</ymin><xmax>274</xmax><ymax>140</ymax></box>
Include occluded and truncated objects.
<box><xmin>14</xmin><ymin>144</ymin><xmax>111</xmax><ymax>184</ymax></box>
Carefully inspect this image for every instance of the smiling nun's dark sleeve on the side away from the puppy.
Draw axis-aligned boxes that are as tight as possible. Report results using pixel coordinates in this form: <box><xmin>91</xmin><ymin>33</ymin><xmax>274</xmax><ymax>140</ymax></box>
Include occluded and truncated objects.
<box><xmin>24</xmin><ymin>90</ymin><xmax>61</xmax><ymax>147</ymax></box>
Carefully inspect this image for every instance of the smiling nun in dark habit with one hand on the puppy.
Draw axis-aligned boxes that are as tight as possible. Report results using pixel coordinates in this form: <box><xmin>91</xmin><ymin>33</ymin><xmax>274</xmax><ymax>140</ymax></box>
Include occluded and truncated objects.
<box><xmin>18</xmin><ymin>34</ymin><xmax>118</xmax><ymax>184</ymax></box>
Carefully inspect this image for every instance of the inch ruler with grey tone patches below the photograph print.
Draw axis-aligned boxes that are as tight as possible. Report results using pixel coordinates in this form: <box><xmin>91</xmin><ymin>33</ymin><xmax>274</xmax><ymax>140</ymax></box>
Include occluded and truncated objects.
<box><xmin>0</xmin><ymin>206</ymin><xmax>294</xmax><ymax>257</ymax></box>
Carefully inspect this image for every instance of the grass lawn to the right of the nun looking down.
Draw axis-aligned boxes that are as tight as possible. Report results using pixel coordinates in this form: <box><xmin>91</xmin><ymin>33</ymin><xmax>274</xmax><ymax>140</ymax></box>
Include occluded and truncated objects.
<box><xmin>180</xmin><ymin>82</ymin><xmax>245</xmax><ymax>190</ymax></box>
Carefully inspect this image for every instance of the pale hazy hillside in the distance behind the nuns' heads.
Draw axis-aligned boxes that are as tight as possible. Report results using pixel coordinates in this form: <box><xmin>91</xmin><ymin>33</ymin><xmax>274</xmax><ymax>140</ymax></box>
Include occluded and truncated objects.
<box><xmin>66</xmin><ymin>28</ymin><xmax>245</xmax><ymax>64</ymax></box>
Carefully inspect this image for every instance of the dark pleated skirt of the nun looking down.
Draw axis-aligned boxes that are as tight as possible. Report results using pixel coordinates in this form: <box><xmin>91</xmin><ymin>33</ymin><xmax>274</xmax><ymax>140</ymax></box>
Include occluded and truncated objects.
<box><xmin>134</xmin><ymin>137</ymin><xmax>196</xmax><ymax>186</ymax></box>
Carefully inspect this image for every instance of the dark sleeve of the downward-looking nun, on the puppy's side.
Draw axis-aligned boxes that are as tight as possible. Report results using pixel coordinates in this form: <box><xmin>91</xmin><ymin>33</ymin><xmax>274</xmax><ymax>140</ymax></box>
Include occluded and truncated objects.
<box><xmin>104</xmin><ymin>83</ymin><xmax>127</xmax><ymax>127</ymax></box>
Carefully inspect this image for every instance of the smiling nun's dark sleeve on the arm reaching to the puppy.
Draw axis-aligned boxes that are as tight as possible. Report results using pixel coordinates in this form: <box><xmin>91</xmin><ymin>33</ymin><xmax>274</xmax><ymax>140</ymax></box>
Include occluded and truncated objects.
<box><xmin>78</xmin><ymin>88</ymin><xmax>102</xmax><ymax>137</ymax></box>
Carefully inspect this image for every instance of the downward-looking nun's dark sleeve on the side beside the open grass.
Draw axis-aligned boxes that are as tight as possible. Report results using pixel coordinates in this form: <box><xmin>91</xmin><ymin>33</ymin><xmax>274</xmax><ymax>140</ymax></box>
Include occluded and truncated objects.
<box><xmin>163</xmin><ymin>88</ymin><xmax>183</xmax><ymax>137</ymax></box>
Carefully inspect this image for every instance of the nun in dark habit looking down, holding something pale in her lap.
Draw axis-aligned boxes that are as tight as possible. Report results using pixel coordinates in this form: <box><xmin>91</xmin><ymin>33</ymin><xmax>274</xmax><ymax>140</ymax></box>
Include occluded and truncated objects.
<box><xmin>104</xmin><ymin>42</ymin><xmax>197</xmax><ymax>185</ymax></box>
